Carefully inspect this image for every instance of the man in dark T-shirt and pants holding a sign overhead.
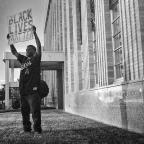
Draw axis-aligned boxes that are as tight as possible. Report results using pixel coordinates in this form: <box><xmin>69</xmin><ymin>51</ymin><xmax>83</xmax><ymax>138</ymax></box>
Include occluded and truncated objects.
<box><xmin>7</xmin><ymin>26</ymin><xmax>42</xmax><ymax>134</ymax></box>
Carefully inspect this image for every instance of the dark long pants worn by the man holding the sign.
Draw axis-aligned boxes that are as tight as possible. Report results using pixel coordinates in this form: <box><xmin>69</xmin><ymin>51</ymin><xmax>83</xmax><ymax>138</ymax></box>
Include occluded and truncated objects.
<box><xmin>21</xmin><ymin>93</ymin><xmax>42</xmax><ymax>132</ymax></box>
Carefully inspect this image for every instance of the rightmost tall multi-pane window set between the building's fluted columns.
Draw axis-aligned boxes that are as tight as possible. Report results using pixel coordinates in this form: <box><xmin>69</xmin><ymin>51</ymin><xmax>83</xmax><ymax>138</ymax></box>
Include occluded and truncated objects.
<box><xmin>111</xmin><ymin>0</ymin><xmax>123</xmax><ymax>79</ymax></box>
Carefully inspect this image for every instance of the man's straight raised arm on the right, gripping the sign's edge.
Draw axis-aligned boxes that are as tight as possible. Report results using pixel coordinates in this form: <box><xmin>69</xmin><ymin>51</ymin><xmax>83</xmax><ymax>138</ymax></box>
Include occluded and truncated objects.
<box><xmin>32</xmin><ymin>26</ymin><xmax>41</xmax><ymax>57</ymax></box>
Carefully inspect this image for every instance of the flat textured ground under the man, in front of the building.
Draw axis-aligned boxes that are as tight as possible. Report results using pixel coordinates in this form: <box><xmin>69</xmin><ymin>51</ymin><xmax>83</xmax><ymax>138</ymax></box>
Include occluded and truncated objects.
<box><xmin>0</xmin><ymin>110</ymin><xmax>144</xmax><ymax>144</ymax></box>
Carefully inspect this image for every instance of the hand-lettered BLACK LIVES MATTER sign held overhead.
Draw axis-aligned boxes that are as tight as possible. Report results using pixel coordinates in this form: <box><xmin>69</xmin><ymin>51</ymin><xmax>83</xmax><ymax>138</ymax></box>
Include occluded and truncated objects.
<box><xmin>8</xmin><ymin>9</ymin><xmax>33</xmax><ymax>44</ymax></box>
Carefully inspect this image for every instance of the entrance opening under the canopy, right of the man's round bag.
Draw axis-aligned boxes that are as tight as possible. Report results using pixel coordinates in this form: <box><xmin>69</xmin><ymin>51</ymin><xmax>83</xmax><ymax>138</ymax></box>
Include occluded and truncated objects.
<box><xmin>41</xmin><ymin>67</ymin><xmax>64</xmax><ymax>110</ymax></box>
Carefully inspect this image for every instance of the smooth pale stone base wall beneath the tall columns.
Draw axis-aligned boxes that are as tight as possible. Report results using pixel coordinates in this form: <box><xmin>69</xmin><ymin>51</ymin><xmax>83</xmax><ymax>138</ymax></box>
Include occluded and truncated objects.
<box><xmin>65</xmin><ymin>81</ymin><xmax>144</xmax><ymax>133</ymax></box>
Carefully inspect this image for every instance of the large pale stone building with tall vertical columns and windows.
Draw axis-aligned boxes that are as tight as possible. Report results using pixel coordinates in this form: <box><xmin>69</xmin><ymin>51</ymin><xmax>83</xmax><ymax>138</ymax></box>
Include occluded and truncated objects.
<box><xmin>2</xmin><ymin>0</ymin><xmax>144</xmax><ymax>133</ymax></box>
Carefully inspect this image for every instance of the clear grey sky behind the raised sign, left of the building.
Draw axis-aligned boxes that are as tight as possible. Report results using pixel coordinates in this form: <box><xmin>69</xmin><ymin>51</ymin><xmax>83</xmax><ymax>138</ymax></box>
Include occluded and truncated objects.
<box><xmin>0</xmin><ymin>0</ymin><xmax>47</xmax><ymax>84</ymax></box>
